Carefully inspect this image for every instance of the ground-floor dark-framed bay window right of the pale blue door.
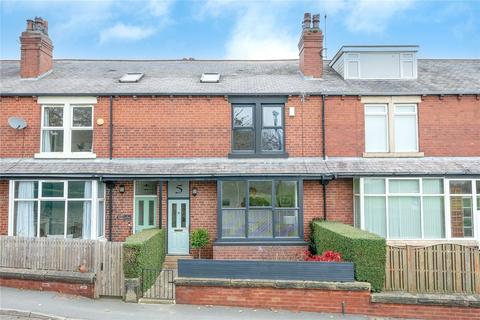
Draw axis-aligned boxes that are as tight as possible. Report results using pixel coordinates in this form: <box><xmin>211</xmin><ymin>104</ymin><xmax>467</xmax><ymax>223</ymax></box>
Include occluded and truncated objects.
<box><xmin>218</xmin><ymin>180</ymin><xmax>303</xmax><ymax>240</ymax></box>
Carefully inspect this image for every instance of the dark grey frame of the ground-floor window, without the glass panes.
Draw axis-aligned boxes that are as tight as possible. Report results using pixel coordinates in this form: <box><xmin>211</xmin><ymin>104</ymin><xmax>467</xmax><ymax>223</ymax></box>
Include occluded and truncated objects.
<box><xmin>216</xmin><ymin>176</ymin><xmax>305</xmax><ymax>244</ymax></box>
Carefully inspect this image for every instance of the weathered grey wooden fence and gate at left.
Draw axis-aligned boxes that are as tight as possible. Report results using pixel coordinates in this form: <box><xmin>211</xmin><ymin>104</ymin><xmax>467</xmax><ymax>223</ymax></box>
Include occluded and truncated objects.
<box><xmin>0</xmin><ymin>236</ymin><xmax>124</xmax><ymax>297</ymax></box>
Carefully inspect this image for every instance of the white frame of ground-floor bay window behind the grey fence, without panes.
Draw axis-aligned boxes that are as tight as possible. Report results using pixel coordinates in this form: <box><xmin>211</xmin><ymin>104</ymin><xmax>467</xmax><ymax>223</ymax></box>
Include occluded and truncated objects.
<box><xmin>8</xmin><ymin>179</ymin><xmax>106</xmax><ymax>240</ymax></box>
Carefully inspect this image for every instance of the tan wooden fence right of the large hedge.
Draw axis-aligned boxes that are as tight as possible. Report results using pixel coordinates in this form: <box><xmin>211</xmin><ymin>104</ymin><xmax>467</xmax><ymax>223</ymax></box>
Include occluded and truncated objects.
<box><xmin>385</xmin><ymin>244</ymin><xmax>480</xmax><ymax>293</ymax></box>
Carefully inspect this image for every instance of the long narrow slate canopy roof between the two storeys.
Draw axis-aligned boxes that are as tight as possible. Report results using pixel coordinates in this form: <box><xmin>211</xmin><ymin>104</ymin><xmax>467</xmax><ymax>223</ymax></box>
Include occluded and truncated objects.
<box><xmin>0</xmin><ymin>157</ymin><xmax>480</xmax><ymax>179</ymax></box>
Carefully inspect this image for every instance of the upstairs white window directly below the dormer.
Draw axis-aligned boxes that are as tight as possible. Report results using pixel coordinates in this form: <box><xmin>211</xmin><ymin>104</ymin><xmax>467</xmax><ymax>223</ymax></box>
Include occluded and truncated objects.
<box><xmin>362</xmin><ymin>97</ymin><xmax>423</xmax><ymax>156</ymax></box>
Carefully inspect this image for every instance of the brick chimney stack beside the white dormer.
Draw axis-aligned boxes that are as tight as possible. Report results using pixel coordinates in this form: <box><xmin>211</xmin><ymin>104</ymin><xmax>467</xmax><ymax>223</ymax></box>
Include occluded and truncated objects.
<box><xmin>298</xmin><ymin>13</ymin><xmax>323</xmax><ymax>78</ymax></box>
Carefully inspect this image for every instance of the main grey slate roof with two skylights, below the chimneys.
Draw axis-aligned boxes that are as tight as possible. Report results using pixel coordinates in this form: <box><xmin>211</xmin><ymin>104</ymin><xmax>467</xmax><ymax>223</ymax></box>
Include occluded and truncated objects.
<box><xmin>0</xmin><ymin>59</ymin><xmax>480</xmax><ymax>96</ymax></box>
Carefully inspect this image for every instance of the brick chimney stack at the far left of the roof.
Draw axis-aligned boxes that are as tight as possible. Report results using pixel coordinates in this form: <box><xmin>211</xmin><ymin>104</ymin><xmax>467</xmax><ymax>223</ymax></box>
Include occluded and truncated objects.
<box><xmin>20</xmin><ymin>17</ymin><xmax>53</xmax><ymax>78</ymax></box>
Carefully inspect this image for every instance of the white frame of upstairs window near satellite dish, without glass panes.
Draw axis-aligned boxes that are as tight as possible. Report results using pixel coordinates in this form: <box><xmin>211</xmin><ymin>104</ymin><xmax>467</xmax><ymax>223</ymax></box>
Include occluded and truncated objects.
<box><xmin>34</xmin><ymin>97</ymin><xmax>97</xmax><ymax>159</ymax></box>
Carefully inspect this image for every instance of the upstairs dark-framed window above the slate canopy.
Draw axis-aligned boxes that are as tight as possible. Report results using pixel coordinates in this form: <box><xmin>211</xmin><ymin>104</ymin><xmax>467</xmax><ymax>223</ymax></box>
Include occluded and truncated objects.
<box><xmin>231</xmin><ymin>98</ymin><xmax>285</xmax><ymax>157</ymax></box>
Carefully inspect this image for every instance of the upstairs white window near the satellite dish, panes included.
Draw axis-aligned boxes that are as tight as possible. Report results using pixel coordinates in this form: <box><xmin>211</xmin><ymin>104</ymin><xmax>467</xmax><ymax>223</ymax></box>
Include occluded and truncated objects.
<box><xmin>35</xmin><ymin>97</ymin><xmax>96</xmax><ymax>158</ymax></box>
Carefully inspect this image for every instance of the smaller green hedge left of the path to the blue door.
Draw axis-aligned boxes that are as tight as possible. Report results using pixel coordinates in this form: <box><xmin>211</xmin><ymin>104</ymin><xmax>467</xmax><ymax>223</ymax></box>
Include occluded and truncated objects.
<box><xmin>123</xmin><ymin>229</ymin><xmax>166</xmax><ymax>289</ymax></box>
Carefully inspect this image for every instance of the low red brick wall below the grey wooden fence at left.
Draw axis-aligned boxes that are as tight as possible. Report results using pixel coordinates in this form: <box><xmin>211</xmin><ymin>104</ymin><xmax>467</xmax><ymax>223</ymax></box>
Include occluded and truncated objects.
<box><xmin>0</xmin><ymin>278</ymin><xmax>95</xmax><ymax>298</ymax></box>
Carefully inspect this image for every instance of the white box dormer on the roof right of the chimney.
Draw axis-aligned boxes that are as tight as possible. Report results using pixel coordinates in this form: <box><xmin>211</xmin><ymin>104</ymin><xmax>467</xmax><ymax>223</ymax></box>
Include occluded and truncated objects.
<box><xmin>329</xmin><ymin>46</ymin><xmax>418</xmax><ymax>80</ymax></box>
